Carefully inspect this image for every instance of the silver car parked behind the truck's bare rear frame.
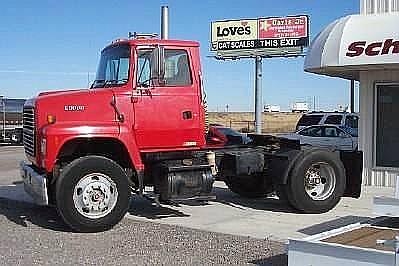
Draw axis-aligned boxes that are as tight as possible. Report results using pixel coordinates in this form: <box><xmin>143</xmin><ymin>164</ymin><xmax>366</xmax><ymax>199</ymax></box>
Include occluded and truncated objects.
<box><xmin>279</xmin><ymin>125</ymin><xmax>357</xmax><ymax>151</ymax></box>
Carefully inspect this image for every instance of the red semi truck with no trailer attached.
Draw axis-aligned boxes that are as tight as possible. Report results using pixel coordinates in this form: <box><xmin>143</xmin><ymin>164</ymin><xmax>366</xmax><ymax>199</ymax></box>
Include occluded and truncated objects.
<box><xmin>20</xmin><ymin>34</ymin><xmax>362</xmax><ymax>232</ymax></box>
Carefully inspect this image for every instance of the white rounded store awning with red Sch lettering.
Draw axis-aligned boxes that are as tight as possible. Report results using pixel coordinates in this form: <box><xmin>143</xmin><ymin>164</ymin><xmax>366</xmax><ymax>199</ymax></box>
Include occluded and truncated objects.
<box><xmin>304</xmin><ymin>13</ymin><xmax>399</xmax><ymax>79</ymax></box>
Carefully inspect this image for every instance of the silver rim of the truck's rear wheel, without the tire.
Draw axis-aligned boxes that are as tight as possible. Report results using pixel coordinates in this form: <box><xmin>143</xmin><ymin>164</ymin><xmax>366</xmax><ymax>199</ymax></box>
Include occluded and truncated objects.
<box><xmin>305</xmin><ymin>162</ymin><xmax>337</xmax><ymax>201</ymax></box>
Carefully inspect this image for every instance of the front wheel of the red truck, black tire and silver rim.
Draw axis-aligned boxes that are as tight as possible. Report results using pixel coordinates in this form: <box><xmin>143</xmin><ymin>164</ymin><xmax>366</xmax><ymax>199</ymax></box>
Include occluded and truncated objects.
<box><xmin>56</xmin><ymin>156</ymin><xmax>130</xmax><ymax>232</ymax></box>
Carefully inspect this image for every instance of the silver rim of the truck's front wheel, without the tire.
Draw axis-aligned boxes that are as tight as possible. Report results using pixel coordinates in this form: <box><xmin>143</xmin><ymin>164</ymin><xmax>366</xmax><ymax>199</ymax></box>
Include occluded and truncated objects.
<box><xmin>73</xmin><ymin>173</ymin><xmax>118</xmax><ymax>219</ymax></box>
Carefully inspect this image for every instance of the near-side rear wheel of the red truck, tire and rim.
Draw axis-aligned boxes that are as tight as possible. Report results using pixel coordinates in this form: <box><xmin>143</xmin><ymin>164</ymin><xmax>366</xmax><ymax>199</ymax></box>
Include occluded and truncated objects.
<box><xmin>285</xmin><ymin>150</ymin><xmax>346</xmax><ymax>213</ymax></box>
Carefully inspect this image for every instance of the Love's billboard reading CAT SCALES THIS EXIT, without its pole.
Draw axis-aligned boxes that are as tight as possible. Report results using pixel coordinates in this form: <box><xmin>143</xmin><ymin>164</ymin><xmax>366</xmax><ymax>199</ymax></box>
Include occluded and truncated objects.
<box><xmin>211</xmin><ymin>15</ymin><xmax>309</xmax><ymax>56</ymax></box>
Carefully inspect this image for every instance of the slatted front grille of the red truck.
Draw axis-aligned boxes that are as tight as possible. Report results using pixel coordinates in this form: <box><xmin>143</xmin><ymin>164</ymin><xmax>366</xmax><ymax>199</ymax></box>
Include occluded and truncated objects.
<box><xmin>23</xmin><ymin>107</ymin><xmax>36</xmax><ymax>157</ymax></box>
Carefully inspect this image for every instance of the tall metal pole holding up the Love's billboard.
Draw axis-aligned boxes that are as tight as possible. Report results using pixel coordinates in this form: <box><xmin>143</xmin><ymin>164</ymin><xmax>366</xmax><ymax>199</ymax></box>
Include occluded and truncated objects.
<box><xmin>255</xmin><ymin>56</ymin><xmax>262</xmax><ymax>134</ymax></box>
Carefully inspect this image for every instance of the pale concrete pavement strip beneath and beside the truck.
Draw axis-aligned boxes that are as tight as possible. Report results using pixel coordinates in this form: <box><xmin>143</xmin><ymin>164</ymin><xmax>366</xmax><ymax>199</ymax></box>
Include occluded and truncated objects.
<box><xmin>127</xmin><ymin>183</ymin><xmax>393</xmax><ymax>242</ymax></box>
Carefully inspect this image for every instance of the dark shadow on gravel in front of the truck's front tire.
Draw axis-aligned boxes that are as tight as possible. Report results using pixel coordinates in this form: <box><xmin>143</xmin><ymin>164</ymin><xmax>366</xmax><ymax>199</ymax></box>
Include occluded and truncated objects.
<box><xmin>0</xmin><ymin>198</ymin><xmax>71</xmax><ymax>232</ymax></box>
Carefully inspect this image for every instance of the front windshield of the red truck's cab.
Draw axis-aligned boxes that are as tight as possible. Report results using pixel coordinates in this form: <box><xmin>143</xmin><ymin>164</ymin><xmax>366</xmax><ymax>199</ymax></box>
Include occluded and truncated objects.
<box><xmin>92</xmin><ymin>45</ymin><xmax>130</xmax><ymax>88</ymax></box>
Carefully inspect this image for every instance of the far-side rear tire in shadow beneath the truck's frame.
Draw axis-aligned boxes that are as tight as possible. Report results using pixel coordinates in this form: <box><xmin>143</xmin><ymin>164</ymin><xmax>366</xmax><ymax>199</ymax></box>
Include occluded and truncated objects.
<box><xmin>224</xmin><ymin>175</ymin><xmax>269</xmax><ymax>198</ymax></box>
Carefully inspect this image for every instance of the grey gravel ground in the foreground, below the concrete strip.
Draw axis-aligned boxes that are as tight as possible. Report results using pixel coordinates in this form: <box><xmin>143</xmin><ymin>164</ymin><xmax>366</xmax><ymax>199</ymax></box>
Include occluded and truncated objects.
<box><xmin>0</xmin><ymin>199</ymin><xmax>287</xmax><ymax>265</ymax></box>
